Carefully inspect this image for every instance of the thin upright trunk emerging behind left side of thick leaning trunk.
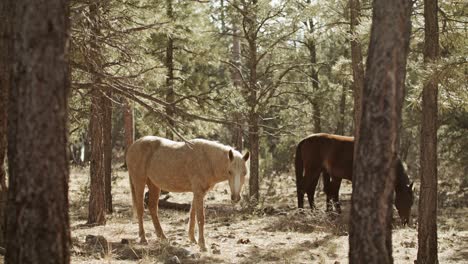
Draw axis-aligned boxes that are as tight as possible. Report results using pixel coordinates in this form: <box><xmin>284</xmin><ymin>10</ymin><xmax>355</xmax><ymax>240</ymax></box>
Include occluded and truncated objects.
<box><xmin>349</xmin><ymin>0</ymin><xmax>364</xmax><ymax>140</ymax></box>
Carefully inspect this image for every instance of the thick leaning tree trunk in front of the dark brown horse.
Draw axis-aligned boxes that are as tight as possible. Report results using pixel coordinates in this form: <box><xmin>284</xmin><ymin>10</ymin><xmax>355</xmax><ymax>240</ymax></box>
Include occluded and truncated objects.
<box><xmin>349</xmin><ymin>0</ymin><xmax>411</xmax><ymax>263</ymax></box>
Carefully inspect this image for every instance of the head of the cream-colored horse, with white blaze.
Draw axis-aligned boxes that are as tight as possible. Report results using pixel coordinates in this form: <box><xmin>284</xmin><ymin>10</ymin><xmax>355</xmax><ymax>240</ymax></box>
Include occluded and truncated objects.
<box><xmin>228</xmin><ymin>149</ymin><xmax>249</xmax><ymax>203</ymax></box>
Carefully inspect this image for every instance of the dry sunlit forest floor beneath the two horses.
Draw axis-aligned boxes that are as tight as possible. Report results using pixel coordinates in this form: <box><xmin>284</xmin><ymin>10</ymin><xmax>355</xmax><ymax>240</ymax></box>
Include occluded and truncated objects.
<box><xmin>70</xmin><ymin>168</ymin><xmax>468</xmax><ymax>263</ymax></box>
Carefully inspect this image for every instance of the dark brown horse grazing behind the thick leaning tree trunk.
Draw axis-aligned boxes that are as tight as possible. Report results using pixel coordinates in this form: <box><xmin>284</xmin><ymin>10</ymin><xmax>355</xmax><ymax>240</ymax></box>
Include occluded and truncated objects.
<box><xmin>295</xmin><ymin>133</ymin><xmax>413</xmax><ymax>224</ymax></box>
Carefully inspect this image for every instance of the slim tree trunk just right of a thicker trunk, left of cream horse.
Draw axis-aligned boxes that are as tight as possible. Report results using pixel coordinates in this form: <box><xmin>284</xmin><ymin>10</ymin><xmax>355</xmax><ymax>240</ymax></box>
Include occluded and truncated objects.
<box><xmin>103</xmin><ymin>89</ymin><xmax>112</xmax><ymax>214</ymax></box>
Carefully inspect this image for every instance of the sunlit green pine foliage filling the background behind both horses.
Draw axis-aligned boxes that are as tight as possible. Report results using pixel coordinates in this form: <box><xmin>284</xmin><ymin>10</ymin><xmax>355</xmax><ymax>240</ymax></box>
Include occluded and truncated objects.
<box><xmin>69</xmin><ymin>0</ymin><xmax>468</xmax><ymax>184</ymax></box>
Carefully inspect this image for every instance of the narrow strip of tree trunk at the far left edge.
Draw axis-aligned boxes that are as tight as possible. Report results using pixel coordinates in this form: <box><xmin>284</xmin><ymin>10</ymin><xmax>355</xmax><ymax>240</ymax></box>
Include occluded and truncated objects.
<box><xmin>0</xmin><ymin>1</ymin><xmax>14</xmax><ymax>247</ymax></box>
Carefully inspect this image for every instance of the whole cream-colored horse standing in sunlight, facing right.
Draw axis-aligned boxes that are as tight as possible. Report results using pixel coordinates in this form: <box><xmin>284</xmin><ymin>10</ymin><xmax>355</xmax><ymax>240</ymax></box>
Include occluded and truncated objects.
<box><xmin>126</xmin><ymin>136</ymin><xmax>249</xmax><ymax>250</ymax></box>
